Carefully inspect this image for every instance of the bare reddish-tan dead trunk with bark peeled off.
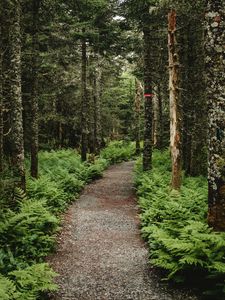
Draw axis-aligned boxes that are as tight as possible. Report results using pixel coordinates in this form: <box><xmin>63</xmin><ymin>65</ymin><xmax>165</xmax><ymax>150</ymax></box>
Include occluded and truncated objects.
<box><xmin>168</xmin><ymin>10</ymin><xmax>182</xmax><ymax>190</ymax></box>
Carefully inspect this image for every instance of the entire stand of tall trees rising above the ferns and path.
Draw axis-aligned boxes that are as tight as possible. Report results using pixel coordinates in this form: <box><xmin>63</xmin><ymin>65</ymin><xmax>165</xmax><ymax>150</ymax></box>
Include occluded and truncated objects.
<box><xmin>0</xmin><ymin>0</ymin><xmax>225</xmax><ymax>230</ymax></box>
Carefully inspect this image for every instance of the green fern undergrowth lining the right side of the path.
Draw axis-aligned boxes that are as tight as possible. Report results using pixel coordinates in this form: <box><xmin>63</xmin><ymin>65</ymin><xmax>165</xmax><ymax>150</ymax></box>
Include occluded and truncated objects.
<box><xmin>136</xmin><ymin>151</ymin><xmax>225</xmax><ymax>299</ymax></box>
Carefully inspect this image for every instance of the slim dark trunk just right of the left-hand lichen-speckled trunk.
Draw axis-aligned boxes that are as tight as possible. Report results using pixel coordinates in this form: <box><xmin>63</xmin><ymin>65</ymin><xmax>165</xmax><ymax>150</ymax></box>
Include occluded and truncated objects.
<box><xmin>30</xmin><ymin>0</ymin><xmax>40</xmax><ymax>178</ymax></box>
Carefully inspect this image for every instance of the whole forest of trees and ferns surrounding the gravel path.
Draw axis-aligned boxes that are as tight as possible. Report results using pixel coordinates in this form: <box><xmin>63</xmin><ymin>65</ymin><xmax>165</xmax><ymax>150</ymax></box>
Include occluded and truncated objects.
<box><xmin>0</xmin><ymin>0</ymin><xmax>225</xmax><ymax>300</ymax></box>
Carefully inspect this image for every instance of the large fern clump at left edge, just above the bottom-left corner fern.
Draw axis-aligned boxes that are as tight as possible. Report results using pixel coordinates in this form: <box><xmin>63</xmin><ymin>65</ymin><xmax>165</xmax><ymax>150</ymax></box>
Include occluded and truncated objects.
<box><xmin>0</xmin><ymin>200</ymin><xmax>59</xmax><ymax>273</ymax></box>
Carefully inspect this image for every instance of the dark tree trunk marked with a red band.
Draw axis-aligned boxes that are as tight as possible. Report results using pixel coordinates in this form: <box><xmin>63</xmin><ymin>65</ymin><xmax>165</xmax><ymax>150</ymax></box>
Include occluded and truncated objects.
<box><xmin>143</xmin><ymin>27</ymin><xmax>153</xmax><ymax>171</ymax></box>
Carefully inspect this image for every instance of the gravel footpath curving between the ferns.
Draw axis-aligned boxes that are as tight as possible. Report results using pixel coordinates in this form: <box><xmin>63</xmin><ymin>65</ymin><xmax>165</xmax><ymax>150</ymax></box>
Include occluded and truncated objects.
<box><xmin>48</xmin><ymin>162</ymin><xmax>197</xmax><ymax>300</ymax></box>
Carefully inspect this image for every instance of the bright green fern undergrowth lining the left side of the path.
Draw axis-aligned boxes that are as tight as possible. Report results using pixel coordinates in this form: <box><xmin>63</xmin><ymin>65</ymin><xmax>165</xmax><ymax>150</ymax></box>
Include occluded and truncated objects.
<box><xmin>0</xmin><ymin>142</ymin><xmax>134</xmax><ymax>300</ymax></box>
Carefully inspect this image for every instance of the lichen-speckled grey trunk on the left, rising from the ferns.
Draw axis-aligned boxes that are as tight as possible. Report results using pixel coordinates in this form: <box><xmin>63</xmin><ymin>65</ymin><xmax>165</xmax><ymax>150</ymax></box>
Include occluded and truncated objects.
<box><xmin>8</xmin><ymin>0</ymin><xmax>25</xmax><ymax>190</ymax></box>
